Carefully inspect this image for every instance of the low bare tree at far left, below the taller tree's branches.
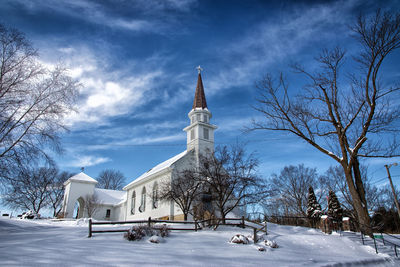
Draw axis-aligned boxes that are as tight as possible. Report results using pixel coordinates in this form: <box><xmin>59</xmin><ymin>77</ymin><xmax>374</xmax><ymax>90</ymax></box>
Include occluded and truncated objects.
<box><xmin>3</xmin><ymin>167</ymin><xmax>57</xmax><ymax>213</ymax></box>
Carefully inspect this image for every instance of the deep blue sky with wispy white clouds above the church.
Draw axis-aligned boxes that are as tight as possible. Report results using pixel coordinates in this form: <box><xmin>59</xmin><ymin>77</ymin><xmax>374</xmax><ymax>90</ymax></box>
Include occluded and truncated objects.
<box><xmin>0</xmin><ymin>0</ymin><xmax>400</xmax><ymax>191</ymax></box>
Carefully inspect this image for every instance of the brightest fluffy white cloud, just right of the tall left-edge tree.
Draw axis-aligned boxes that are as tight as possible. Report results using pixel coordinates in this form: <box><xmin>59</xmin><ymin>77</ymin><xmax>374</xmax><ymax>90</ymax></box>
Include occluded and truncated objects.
<box><xmin>46</xmin><ymin>47</ymin><xmax>163</xmax><ymax>126</ymax></box>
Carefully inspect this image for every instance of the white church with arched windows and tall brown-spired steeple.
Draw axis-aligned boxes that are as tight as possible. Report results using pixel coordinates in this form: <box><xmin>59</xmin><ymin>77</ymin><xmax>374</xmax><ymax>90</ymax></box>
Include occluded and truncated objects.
<box><xmin>63</xmin><ymin>69</ymin><xmax>217</xmax><ymax>221</ymax></box>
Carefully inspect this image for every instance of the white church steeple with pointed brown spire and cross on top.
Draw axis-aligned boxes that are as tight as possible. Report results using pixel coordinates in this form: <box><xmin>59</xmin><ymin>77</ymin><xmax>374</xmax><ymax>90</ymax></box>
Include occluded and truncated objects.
<box><xmin>183</xmin><ymin>66</ymin><xmax>217</xmax><ymax>155</ymax></box>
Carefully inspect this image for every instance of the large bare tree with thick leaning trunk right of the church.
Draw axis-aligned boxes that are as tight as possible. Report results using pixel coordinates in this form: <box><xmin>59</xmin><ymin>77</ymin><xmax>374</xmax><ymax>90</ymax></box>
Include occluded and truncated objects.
<box><xmin>252</xmin><ymin>10</ymin><xmax>400</xmax><ymax>234</ymax></box>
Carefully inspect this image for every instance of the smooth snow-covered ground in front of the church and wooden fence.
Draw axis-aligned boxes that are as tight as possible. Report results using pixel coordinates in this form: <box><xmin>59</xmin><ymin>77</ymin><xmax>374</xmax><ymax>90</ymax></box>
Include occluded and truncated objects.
<box><xmin>0</xmin><ymin>218</ymin><xmax>399</xmax><ymax>266</ymax></box>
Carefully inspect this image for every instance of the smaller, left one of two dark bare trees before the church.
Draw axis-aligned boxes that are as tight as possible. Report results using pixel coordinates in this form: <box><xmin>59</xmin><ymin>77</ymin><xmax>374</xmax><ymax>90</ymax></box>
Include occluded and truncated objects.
<box><xmin>159</xmin><ymin>169</ymin><xmax>201</xmax><ymax>221</ymax></box>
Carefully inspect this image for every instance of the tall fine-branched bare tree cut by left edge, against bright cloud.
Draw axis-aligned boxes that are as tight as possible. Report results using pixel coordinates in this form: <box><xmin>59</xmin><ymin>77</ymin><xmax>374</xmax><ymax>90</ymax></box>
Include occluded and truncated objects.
<box><xmin>0</xmin><ymin>24</ymin><xmax>78</xmax><ymax>178</ymax></box>
